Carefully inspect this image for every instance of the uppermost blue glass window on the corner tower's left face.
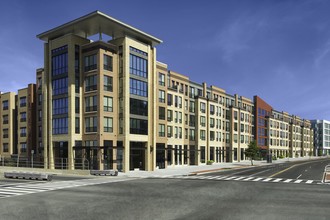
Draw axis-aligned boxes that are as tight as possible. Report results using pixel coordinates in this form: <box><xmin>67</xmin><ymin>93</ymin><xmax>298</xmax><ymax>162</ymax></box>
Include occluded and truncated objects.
<box><xmin>52</xmin><ymin>46</ymin><xmax>68</xmax><ymax>76</ymax></box>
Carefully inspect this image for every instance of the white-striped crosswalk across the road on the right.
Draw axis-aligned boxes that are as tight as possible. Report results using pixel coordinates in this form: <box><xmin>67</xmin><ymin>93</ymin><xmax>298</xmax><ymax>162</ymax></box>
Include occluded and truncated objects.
<box><xmin>150</xmin><ymin>175</ymin><xmax>321</xmax><ymax>184</ymax></box>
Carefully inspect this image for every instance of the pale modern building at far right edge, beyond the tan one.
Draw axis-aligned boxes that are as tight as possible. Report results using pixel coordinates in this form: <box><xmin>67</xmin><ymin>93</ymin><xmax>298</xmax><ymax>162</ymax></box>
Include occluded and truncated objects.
<box><xmin>311</xmin><ymin>120</ymin><xmax>330</xmax><ymax>156</ymax></box>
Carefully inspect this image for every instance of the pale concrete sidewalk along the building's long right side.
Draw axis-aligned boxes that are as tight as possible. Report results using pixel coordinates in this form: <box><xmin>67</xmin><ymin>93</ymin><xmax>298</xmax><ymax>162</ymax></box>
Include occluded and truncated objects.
<box><xmin>118</xmin><ymin>156</ymin><xmax>323</xmax><ymax>177</ymax></box>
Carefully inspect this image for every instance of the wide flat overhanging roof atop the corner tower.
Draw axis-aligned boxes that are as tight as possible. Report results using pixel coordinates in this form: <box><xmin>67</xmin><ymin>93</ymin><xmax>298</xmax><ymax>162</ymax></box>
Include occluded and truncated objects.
<box><xmin>37</xmin><ymin>11</ymin><xmax>162</xmax><ymax>47</ymax></box>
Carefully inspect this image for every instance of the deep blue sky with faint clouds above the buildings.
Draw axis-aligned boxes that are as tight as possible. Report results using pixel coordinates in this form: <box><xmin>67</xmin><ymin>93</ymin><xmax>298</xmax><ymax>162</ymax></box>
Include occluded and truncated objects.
<box><xmin>0</xmin><ymin>0</ymin><xmax>330</xmax><ymax>120</ymax></box>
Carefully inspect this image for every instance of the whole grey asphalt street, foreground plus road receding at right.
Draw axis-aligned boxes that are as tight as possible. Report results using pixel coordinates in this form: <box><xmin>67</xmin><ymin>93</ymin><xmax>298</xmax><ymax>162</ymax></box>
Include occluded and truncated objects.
<box><xmin>0</xmin><ymin>160</ymin><xmax>330</xmax><ymax>219</ymax></box>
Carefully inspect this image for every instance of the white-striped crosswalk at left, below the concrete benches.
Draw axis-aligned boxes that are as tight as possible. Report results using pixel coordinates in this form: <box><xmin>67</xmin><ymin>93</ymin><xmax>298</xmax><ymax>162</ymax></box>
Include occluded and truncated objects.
<box><xmin>0</xmin><ymin>177</ymin><xmax>133</xmax><ymax>199</ymax></box>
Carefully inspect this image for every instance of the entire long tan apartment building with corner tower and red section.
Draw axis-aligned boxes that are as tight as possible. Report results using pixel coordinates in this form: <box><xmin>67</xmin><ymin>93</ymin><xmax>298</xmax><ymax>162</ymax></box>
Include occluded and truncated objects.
<box><xmin>0</xmin><ymin>11</ymin><xmax>313</xmax><ymax>172</ymax></box>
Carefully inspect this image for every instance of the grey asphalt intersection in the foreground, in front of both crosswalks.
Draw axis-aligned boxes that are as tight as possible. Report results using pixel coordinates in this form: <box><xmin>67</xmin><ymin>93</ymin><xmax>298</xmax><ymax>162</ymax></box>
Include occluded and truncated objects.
<box><xmin>0</xmin><ymin>179</ymin><xmax>330</xmax><ymax>220</ymax></box>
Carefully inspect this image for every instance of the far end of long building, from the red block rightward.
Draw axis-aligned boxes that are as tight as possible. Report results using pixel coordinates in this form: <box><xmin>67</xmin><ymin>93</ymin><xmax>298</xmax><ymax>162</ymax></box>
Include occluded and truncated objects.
<box><xmin>254</xmin><ymin>96</ymin><xmax>314</xmax><ymax>157</ymax></box>
